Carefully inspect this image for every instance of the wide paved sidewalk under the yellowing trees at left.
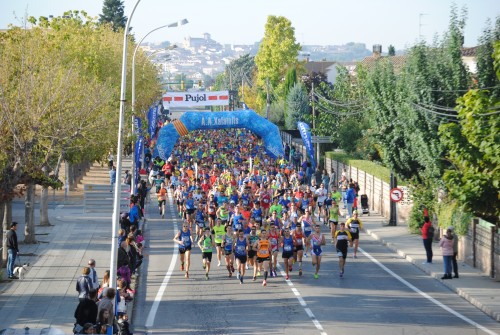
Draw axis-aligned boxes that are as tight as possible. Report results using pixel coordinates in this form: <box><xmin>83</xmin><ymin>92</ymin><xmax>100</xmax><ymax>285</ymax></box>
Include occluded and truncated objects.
<box><xmin>0</xmin><ymin>192</ymin><xmax>141</xmax><ymax>334</ymax></box>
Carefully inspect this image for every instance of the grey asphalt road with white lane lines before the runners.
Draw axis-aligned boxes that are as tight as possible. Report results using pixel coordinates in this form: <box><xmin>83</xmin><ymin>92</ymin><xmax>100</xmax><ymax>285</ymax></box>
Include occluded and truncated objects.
<box><xmin>133</xmin><ymin>197</ymin><xmax>500</xmax><ymax>335</ymax></box>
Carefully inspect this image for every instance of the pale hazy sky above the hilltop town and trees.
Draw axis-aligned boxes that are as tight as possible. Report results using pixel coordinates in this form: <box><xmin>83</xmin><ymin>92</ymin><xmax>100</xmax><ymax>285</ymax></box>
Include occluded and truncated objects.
<box><xmin>0</xmin><ymin>0</ymin><xmax>500</xmax><ymax>51</ymax></box>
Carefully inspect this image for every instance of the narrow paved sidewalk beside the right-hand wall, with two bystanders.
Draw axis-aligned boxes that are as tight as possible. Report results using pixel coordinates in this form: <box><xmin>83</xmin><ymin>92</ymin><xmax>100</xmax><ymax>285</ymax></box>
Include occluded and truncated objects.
<box><xmin>360</xmin><ymin>213</ymin><xmax>500</xmax><ymax>322</ymax></box>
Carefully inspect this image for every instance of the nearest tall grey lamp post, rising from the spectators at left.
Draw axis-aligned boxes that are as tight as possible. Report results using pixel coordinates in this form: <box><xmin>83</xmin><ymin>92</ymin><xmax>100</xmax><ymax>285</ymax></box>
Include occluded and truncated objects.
<box><xmin>109</xmin><ymin>0</ymin><xmax>141</xmax><ymax>306</ymax></box>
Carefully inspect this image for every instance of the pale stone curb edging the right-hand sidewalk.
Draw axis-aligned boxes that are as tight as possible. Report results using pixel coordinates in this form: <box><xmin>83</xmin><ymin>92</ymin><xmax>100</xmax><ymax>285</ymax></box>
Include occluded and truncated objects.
<box><xmin>363</xmin><ymin>229</ymin><xmax>500</xmax><ymax>322</ymax></box>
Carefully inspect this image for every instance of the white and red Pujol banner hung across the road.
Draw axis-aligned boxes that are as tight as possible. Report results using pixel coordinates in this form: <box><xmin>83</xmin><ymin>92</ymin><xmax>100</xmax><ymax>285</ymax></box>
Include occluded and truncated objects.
<box><xmin>163</xmin><ymin>91</ymin><xmax>229</xmax><ymax>109</ymax></box>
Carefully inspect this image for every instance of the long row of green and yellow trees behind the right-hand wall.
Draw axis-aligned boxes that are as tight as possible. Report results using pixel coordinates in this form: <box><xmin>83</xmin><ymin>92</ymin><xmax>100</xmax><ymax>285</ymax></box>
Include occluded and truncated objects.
<box><xmin>217</xmin><ymin>7</ymin><xmax>500</xmax><ymax>231</ymax></box>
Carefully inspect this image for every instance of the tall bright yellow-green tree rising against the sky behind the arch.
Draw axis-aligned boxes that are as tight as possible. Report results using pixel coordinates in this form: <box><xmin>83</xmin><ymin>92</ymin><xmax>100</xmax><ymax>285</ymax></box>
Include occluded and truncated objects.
<box><xmin>255</xmin><ymin>15</ymin><xmax>301</xmax><ymax>88</ymax></box>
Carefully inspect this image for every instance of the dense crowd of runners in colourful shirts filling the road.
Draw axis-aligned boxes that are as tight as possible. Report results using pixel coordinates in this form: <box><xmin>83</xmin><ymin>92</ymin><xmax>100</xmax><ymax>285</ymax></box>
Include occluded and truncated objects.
<box><xmin>149</xmin><ymin>129</ymin><xmax>363</xmax><ymax>286</ymax></box>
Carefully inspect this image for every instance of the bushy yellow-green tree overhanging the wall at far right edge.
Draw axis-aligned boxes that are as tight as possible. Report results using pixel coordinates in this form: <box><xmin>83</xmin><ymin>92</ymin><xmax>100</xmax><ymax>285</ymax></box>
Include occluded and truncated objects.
<box><xmin>440</xmin><ymin>80</ymin><xmax>500</xmax><ymax>224</ymax></box>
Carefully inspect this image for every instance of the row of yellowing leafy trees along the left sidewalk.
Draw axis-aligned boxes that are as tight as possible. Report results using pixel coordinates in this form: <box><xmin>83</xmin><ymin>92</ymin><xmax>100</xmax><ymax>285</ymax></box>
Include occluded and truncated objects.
<box><xmin>0</xmin><ymin>7</ymin><xmax>161</xmax><ymax>262</ymax></box>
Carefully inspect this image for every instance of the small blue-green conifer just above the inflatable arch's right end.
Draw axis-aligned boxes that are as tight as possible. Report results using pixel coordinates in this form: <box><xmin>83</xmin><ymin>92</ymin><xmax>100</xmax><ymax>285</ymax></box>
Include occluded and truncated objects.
<box><xmin>285</xmin><ymin>83</ymin><xmax>311</xmax><ymax>129</ymax></box>
